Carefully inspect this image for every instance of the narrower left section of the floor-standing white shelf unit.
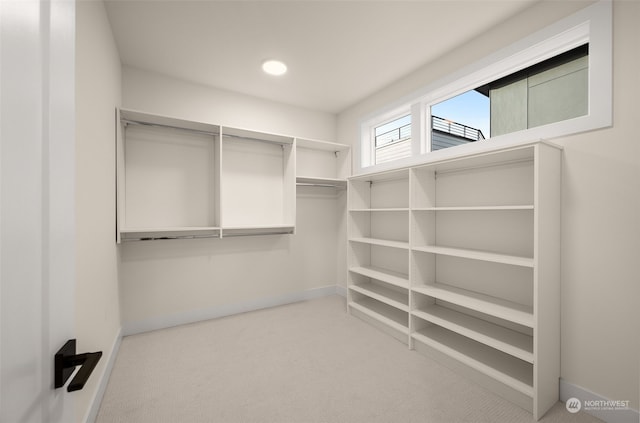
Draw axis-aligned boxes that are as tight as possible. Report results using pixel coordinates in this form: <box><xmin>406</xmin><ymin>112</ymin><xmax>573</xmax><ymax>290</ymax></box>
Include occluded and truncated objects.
<box><xmin>347</xmin><ymin>170</ymin><xmax>409</xmax><ymax>342</ymax></box>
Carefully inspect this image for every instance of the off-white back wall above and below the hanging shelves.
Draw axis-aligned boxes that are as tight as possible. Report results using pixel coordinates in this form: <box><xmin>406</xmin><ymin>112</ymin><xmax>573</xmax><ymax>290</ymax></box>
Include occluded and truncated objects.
<box><xmin>120</xmin><ymin>67</ymin><xmax>344</xmax><ymax>333</ymax></box>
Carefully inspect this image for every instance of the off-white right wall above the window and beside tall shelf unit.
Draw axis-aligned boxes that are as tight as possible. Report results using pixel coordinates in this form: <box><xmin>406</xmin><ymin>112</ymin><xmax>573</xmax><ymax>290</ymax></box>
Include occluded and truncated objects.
<box><xmin>338</xmin><ymin>1</ymin><xmax>640</xmax><ymax>418</ymax></box>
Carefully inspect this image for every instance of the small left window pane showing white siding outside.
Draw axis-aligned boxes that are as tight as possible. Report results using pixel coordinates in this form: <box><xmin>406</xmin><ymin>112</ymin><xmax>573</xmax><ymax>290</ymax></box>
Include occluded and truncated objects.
<box><xmin>374</xmin><ymin>115</ymin><xmax>411</xmax><ymax>164</ymax></box>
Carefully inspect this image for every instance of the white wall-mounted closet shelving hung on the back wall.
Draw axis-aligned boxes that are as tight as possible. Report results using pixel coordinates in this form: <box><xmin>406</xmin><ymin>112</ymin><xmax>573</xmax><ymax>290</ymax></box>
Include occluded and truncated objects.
<box><xmin>117</xmin><ymin>110</ymin><xmax>350</xmax><ymax>242</ymax></box>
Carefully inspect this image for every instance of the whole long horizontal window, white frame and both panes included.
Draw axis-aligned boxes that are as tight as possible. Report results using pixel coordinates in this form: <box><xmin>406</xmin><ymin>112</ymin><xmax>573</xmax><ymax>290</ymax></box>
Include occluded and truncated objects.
<box><xmin>355</xmin><ymin>0</ymin><xmax>612</xmax><ymax>173</ymax></box>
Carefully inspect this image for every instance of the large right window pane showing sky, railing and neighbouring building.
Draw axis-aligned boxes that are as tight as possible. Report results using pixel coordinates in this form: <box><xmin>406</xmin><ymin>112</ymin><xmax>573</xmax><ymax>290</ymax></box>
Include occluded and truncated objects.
<box><xmin>431</xmin><ymin>44</ymin><xmax>589</xmax><ymax>151</ymax></box>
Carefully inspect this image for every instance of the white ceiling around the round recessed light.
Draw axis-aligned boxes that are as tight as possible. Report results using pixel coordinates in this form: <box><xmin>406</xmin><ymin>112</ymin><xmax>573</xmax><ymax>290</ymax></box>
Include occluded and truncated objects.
<box><xmin>106</xmin><ymin>0</ymin><xmax>538</xmax><ymax>113</ymax></box>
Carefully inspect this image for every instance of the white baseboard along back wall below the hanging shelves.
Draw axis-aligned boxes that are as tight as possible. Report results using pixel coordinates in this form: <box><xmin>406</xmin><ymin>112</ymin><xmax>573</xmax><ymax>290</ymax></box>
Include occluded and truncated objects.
<box><xmin>123</xmin><ymin>285</ymin><xmax>337</xmax><ymax>336</ymax></box>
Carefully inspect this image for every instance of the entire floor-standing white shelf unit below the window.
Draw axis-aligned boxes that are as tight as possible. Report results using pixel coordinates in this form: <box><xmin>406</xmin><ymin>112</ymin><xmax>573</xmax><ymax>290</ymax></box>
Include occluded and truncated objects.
<box><xmin>348</xmin><ymin>142</ymin><xmax>562</xmax><ymax>420</ymax></box>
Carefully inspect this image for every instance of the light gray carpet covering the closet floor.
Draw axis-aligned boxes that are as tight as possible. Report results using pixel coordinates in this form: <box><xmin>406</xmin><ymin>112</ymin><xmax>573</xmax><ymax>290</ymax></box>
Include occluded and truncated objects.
<box><xmin>97</xmin><ymin>296</ymin><xmax>600</xmax><ymax>423</ymax></box>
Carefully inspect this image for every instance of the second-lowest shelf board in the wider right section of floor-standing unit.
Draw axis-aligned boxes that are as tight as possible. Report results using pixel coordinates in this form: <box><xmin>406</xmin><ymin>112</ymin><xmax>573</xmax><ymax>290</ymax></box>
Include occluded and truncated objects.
<box><xmin>412</xmin><ymin>304</ymin><xmax>533</xmax><ymax>364</ymax></box>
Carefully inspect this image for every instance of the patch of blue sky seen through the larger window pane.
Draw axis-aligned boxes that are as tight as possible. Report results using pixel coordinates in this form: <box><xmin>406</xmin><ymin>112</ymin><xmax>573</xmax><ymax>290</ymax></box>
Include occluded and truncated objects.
<box><xmin>431</xmin><ymin>90</ymin><xmax>491</xmax><ymax>138</ymax></box>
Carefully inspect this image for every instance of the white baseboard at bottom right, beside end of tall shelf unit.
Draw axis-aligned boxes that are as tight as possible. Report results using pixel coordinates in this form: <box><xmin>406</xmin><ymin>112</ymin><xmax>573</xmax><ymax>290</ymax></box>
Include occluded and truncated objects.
<box><xmin>560</xmin><ymin>379</ymin><xmax>640</xmax><ymax>423</ymax></box>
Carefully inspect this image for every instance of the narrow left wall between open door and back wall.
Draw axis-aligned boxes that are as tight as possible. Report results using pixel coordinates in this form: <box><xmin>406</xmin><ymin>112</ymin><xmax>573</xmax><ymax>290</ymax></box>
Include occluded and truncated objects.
<box><xmin>73</xmin><ymin>1</ymin><xmax>121</xmax><ymax>421</ymax></box>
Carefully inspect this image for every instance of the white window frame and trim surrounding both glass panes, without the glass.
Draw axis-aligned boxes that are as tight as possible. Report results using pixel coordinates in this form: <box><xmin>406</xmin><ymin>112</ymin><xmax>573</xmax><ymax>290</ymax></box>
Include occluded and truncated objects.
<box><xmin>354</xmin><ymin>0</ymin><xmax>613</xmax><ymax>174</ymax></box>
